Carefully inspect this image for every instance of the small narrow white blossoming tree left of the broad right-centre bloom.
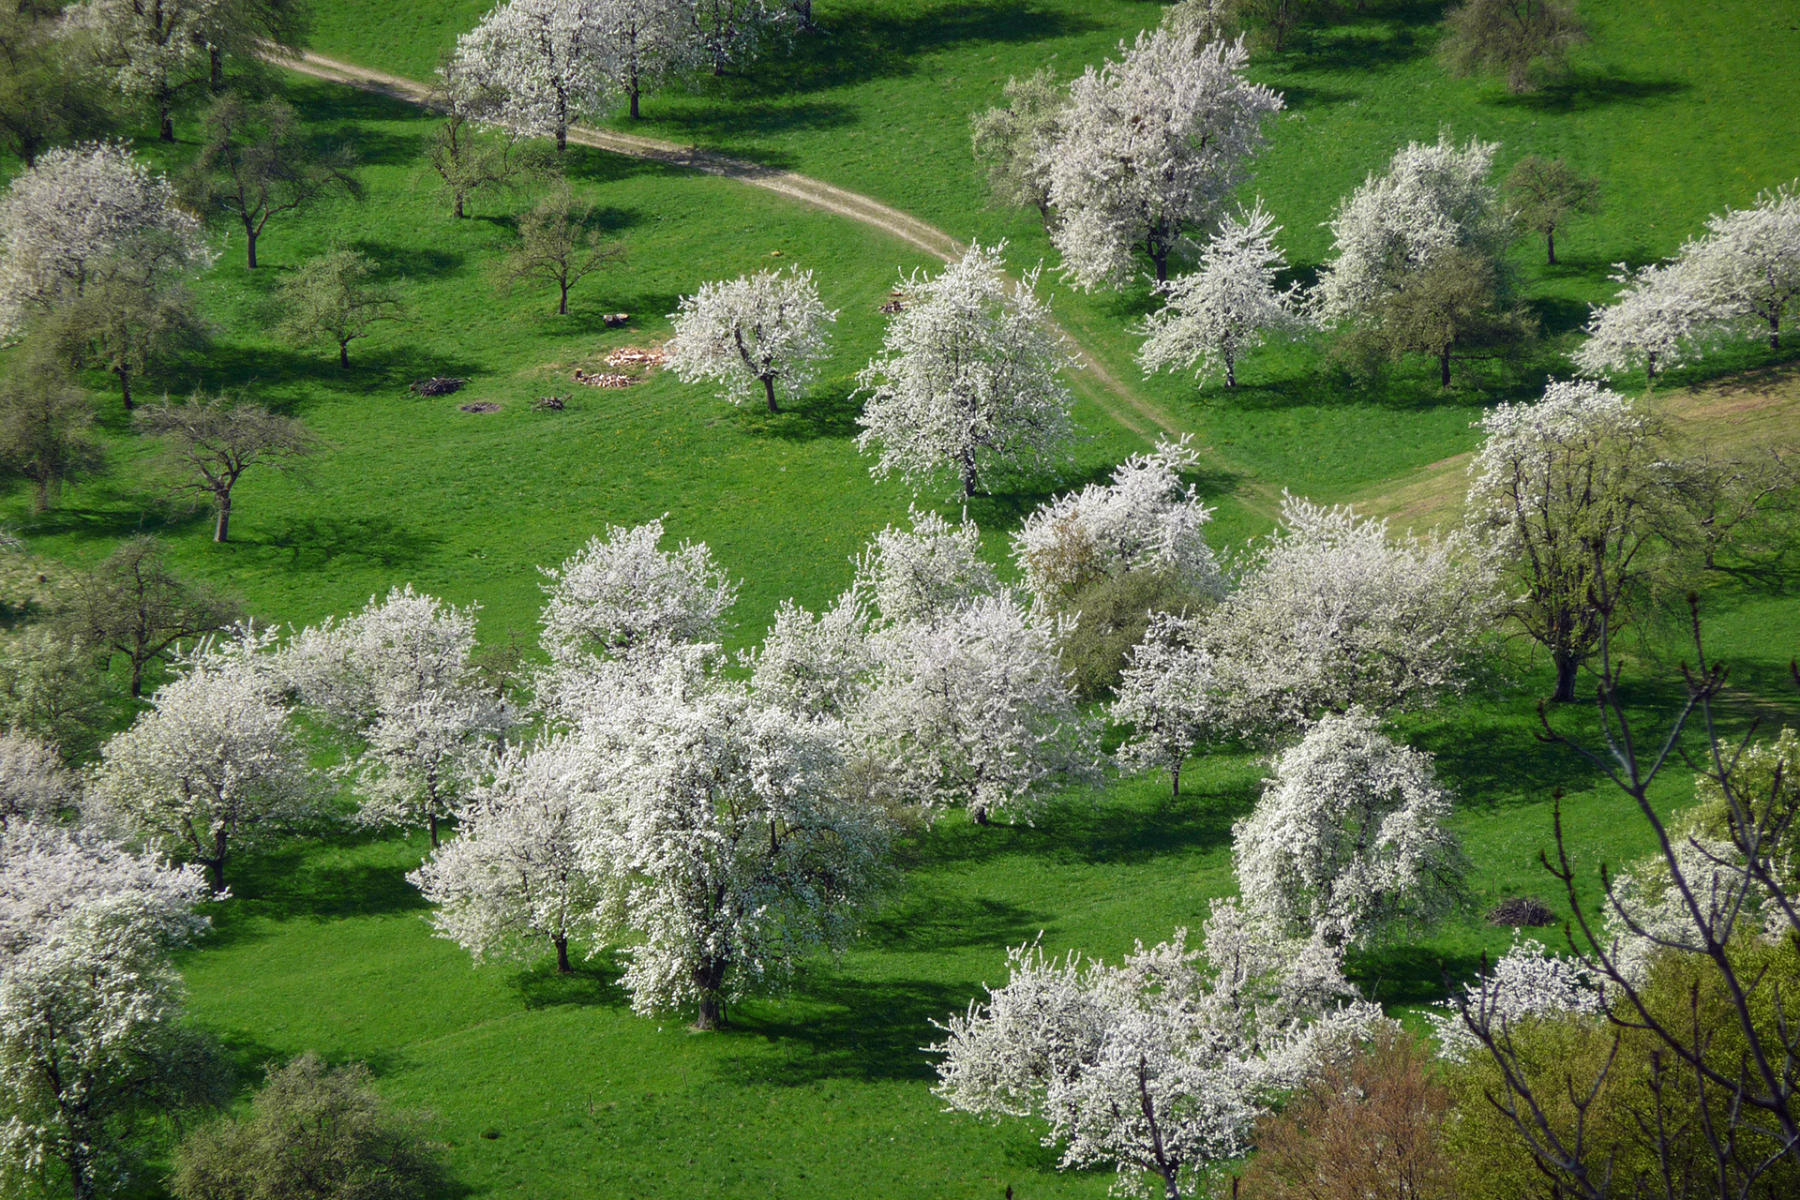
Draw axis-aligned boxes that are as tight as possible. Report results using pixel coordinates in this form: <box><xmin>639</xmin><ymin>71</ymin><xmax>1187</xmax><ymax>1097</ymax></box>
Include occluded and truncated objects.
<box><xmin>1111</xmin><ymin>612</ymin><xmax>1220</xmax><ymax>797</ymax></box>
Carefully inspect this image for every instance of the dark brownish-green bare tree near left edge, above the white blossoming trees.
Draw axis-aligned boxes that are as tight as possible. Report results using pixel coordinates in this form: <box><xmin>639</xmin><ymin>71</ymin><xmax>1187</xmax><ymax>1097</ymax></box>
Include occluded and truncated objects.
<box><xmin>65</xmin><ymin>534</ymin><xmax>243</xmax><ymax>696</ymax></box>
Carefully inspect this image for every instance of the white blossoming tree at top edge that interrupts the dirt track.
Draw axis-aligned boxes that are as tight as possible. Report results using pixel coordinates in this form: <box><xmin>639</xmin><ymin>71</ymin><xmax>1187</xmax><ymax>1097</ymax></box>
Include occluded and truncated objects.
<box><xmin>454</xmin><ymin>0</ymin><xmax>610</xmax><ymax>151</ymax></box>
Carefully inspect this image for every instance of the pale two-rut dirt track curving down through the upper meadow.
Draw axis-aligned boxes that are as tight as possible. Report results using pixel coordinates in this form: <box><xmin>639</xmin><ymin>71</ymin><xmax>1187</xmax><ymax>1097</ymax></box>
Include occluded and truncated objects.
<box><xmin>284</xmin><ymin>50</ymin><xmax>1276</xmax><ymax>496</ymax></box>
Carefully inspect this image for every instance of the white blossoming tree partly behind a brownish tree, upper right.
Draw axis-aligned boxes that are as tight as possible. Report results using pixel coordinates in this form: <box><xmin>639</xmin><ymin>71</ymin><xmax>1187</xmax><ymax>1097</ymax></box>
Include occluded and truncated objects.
<box><xmin>1312</xmin><ymin>131</ymin><xmax>1510</xmax><ymax>322</ymax></box>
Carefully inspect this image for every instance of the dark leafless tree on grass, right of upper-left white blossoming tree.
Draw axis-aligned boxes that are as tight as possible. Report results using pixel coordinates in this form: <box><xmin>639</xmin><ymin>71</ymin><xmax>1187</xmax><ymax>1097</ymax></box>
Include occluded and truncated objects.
<box><xmin>187</xmin><ymin>92</ymin><xmax>362</xmax><ymax>270</ymax></box>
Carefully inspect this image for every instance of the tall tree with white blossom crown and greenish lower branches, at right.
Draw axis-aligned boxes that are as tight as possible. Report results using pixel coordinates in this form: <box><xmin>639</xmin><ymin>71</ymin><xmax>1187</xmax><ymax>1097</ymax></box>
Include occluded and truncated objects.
<box><xmin>1469</xmin><ymin>383</ymin><xmax>1672</xmax><ymax>702</ymax></box>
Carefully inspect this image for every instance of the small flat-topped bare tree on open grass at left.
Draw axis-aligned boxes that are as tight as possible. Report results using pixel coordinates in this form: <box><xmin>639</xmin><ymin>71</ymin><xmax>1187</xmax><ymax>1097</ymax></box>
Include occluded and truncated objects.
<box><xmin>137</xmin><ymin>396</ymin><xmax>319</xmax><ymax>542</ymax></box>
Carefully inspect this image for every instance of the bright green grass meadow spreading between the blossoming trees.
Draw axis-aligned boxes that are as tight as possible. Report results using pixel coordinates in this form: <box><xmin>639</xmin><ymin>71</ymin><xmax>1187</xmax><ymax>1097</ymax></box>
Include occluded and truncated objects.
<box><xmin>0</xmin><ymin>0</ymin><xmax>1800</xmax><ymax>1200</ymax></box>
